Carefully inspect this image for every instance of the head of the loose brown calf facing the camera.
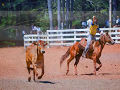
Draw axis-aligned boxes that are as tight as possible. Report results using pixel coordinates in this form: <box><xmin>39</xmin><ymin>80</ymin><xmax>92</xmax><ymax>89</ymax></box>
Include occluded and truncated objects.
<box><xmin>37</xmin><ymin>40</ymin><xmax>47</xmax><ymax>54</ymax></box>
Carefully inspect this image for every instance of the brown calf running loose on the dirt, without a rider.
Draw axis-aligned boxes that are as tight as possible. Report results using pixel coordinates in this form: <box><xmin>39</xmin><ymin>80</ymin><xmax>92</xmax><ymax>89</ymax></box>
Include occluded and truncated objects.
<box><xmin>26</xmin><ymin>40</ymin><xmax>47</xmax><ymax>82</ymax></box>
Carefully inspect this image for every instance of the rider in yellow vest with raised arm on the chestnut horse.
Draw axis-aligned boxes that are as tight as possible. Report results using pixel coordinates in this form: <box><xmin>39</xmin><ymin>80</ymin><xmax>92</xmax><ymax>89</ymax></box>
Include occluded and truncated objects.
<box><xmin>82</xmin><ymin>16</ymin><xmax>100</xmax><ymax>57</ymax></box>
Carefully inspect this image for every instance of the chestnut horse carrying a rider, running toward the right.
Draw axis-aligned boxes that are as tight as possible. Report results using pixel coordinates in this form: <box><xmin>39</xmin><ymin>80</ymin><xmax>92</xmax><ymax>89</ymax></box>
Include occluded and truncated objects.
<box><xmin>60</xmin><ymin>32</ymin><xmax>114</xmax><ymax>75</ymax></box>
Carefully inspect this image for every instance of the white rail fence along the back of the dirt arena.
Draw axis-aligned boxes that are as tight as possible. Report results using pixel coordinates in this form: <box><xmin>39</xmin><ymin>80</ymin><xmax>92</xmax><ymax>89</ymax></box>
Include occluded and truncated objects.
<box><xmin>24</xmin><ymin>28</ymin><xmax>120</xmax><ymax>47</ymax></box>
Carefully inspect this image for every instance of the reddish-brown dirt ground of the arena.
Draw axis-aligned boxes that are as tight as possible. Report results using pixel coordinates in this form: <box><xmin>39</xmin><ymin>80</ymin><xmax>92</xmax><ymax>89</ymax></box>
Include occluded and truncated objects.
<box><xmin>0</xmin><ymin>44</ymin><xmax>120</xmax><ymax>90</ymax></box>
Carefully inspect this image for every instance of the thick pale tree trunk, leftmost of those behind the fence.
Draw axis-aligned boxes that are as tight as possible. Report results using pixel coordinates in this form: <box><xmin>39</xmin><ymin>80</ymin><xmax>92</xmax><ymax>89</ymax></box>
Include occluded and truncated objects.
<box><xmin>48</xmin><ymin>0</ymin><xmax>53</xmax><ymax>30</ymax></box>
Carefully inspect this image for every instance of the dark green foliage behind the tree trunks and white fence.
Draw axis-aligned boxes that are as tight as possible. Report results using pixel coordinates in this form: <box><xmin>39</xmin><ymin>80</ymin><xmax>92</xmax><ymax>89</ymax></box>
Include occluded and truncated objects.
<box><xmin>0</xmin><ymin>0</ymin><xmax>120</xmax><ymax>41</ymax></box>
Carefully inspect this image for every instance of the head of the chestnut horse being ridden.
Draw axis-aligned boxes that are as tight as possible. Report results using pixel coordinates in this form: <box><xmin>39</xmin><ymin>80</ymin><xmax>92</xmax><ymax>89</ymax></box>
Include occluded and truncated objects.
<box><xmin>100</xmin><ymin>32</ymin><xmax>115</xmax><ymax>45</ymax></box>
